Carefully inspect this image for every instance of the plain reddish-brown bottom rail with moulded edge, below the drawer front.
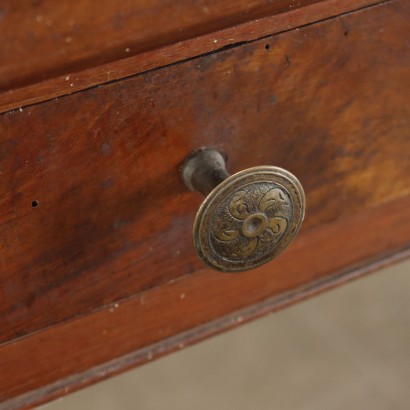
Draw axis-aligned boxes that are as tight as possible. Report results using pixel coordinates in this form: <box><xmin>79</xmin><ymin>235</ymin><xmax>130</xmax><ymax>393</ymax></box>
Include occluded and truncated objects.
<box><xmin>0</xmin><ymin>196</ymin><xmax>410</xmax><ymax>410</ymax></box>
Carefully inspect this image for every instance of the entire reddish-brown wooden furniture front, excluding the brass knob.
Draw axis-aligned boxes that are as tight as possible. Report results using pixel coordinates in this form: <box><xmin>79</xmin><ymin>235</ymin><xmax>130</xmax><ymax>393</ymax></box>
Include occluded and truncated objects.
<box><xmin>0</xmin><ymin>0</ymin><xmax>410</xmax><ymax>409</ymax></box>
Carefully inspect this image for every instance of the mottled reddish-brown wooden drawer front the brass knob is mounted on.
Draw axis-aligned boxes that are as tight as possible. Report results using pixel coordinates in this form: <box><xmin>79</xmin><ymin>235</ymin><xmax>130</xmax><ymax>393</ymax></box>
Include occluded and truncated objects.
<box><xmin>0</xmin><ymin>1</ymin><xmax>410</xmax><ymax>342</ymax></box>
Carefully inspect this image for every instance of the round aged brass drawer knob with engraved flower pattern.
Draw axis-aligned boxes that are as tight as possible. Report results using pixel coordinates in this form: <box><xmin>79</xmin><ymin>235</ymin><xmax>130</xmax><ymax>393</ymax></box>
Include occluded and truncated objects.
<box><xmin>181</xmin><ymin>148</ymin><xmax>305</xmax><ymax>272</ymax></box>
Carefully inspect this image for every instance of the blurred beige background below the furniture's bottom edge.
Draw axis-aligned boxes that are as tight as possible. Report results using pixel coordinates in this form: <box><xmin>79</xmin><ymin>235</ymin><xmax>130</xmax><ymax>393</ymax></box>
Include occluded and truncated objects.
<box><xmin>44</xmin><ymin>261</ymin><xmax>410</xmax><ymax>410</ymax></box>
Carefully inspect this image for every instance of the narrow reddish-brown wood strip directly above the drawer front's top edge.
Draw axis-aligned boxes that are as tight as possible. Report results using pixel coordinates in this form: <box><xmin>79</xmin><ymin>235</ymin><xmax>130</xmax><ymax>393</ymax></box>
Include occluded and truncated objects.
<box><xmin>0</xmin><ymin>0</ymin><xmax>393</xmax><ymax>114</ymax></box>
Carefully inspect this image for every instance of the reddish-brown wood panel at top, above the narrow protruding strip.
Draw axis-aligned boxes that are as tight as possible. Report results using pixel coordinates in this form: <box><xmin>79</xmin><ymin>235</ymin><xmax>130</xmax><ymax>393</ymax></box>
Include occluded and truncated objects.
<box><xmin>0</xmin><ymin>0</ymin><xmax>330</xmax><ymax>90</ymax></box>
